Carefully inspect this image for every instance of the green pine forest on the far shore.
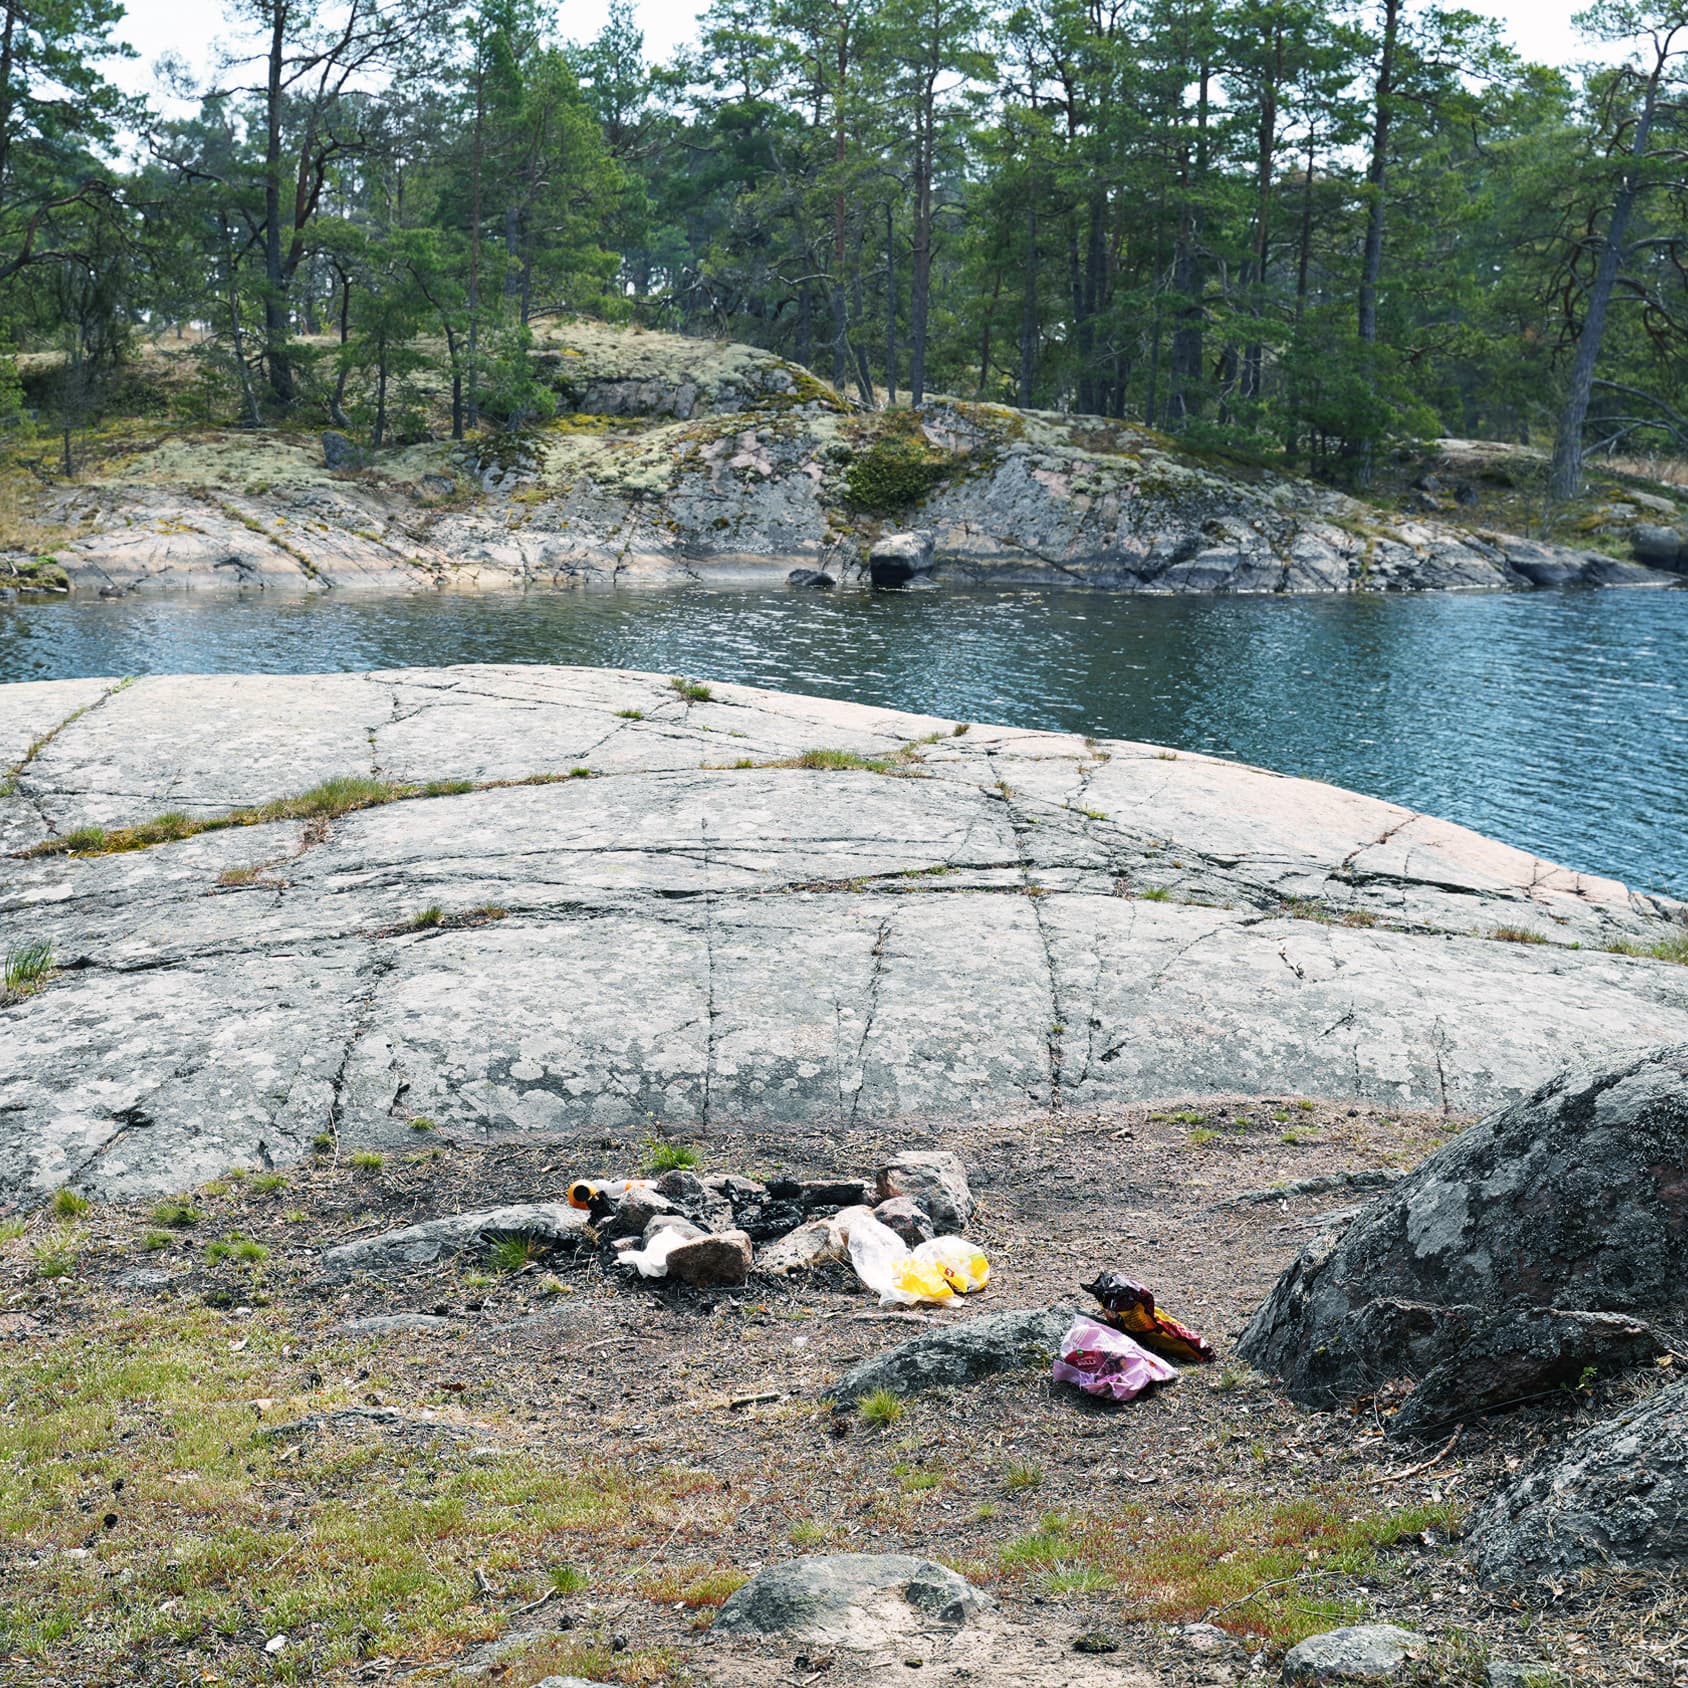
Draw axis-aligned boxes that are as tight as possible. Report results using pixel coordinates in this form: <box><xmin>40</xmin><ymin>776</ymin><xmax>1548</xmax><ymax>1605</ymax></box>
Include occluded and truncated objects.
<box><xmin>0</xmin><ymin>0</ymin><xmax>1688</xmax><ymax>495</ymax></box>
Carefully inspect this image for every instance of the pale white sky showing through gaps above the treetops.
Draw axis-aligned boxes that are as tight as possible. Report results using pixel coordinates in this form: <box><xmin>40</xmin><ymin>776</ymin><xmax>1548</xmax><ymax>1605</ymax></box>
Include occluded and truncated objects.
<box><xmin>105</xmin><ymin>0</ymin><xmax>1590</xmax><ymax>93</ymax></box>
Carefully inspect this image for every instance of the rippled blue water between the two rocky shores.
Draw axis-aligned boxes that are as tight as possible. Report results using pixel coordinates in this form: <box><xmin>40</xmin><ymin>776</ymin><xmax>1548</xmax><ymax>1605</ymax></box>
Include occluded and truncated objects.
<box><xmin>0</xmin><ymin>587</ymin><xmax>1688</xmax><ymax>895</ymax></box>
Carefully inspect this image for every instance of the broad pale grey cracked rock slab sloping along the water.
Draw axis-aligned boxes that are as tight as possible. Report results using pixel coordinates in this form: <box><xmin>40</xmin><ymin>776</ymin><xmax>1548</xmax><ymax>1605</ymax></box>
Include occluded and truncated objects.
<box><xmin>0</xmin><ymin>667</ymin><xmax>1688</xmax><ymax>1202</ymax></box>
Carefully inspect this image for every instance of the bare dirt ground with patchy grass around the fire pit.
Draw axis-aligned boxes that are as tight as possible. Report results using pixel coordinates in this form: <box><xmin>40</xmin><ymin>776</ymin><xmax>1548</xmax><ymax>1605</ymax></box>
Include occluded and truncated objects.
<box><xmin>0</xmin><ymin>1097</ymin><xmax>1688</xmax><ymax>1688</ymax></box>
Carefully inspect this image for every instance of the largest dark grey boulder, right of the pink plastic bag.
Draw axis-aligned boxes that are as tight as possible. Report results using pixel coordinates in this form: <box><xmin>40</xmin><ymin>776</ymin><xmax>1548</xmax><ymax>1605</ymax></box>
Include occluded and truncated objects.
<box><xmin>1237</xmin><ymin>1045</ymin><xmax>1688</xmax><ymax>1431</ymax></box>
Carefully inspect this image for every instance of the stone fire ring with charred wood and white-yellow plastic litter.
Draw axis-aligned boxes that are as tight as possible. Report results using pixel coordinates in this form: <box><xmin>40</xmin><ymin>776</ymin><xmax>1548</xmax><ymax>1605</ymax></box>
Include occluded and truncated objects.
<box><xmin>569</xmin><ymin>1150</ymin><xmax>991</xmax><ymax>1307</ymax></box>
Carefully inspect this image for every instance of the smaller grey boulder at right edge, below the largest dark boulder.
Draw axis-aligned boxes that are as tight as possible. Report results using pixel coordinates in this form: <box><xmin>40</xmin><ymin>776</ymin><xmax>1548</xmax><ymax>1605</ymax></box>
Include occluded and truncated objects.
<box><xmin>1467</xmin><ymin>1379</ymin><xmax>1688</xmax><ymax>1582</ymax></box>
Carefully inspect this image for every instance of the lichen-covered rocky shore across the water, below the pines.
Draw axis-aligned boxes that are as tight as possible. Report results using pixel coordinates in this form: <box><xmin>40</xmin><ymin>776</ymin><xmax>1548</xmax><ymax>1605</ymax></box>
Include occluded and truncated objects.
<box><xmin>16</xmin><ymin>322</ymin><xmax>1681</xmax><ymax>594</ymax></box>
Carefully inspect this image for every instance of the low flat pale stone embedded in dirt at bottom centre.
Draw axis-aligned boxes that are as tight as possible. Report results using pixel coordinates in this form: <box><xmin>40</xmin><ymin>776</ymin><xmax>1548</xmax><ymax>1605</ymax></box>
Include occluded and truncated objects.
<box><xmin>711</xmin><ymin>1553</ymin><xmax>991</xmax><ymax>1647</ymax></box>
